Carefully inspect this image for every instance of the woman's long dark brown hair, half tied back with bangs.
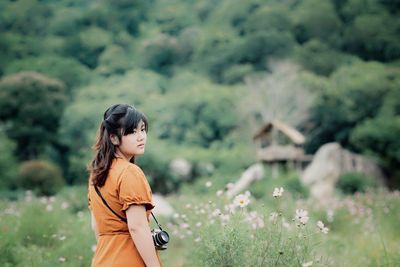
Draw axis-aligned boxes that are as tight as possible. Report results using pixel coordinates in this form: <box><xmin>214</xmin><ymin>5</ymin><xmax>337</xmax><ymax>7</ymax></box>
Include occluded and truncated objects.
<box><xmin>88</xmin><ymin>104</ymin><xmax>148</xmax><ymax>187</ymax></box>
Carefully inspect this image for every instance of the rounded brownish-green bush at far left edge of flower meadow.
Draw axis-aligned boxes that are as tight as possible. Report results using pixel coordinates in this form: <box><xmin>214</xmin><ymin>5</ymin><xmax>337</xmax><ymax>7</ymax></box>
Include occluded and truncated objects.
<box><xmin>17</xmin><ymin>160</ymin><xmax>64</xmax><ymax>195</ymax></box>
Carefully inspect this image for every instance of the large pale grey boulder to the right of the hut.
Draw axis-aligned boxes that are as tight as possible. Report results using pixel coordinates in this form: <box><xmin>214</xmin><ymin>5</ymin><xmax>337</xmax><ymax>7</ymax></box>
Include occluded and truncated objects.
<box><xmin>301</xmin><ymin>143</ymin><xmax>383</xmax><ymax>200</ymax></box>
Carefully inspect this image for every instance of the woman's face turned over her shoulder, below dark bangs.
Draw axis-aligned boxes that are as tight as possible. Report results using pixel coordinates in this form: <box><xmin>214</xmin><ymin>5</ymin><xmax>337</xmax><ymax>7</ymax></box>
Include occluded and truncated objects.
<box><xmin>118</xmin><ymin>121</ymin><xmax>147</xmax><ymax>158</ymax></box>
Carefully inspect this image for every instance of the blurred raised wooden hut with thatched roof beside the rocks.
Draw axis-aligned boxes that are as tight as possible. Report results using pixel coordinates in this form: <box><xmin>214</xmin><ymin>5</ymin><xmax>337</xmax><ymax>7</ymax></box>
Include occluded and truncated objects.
<box><xmin>253</xmin><ymin>120</ymin><xmax>312</xmax><ymax>176</ymax></box>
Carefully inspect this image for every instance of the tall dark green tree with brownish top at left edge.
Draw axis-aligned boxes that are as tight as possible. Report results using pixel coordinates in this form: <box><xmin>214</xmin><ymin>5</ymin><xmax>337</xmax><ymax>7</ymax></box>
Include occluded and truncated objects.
<box><xmin>0</xmin><ymin>72</ymin><xmax>67</xmax><ymax>159</ymax></box>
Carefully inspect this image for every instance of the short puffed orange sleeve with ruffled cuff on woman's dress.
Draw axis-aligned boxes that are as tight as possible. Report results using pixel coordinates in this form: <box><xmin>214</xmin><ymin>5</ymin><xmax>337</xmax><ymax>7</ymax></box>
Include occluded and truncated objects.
<box><xmin>119</xmin><ymin>164</ymin><xmax>154</xmax><ymax>211</ymax></box>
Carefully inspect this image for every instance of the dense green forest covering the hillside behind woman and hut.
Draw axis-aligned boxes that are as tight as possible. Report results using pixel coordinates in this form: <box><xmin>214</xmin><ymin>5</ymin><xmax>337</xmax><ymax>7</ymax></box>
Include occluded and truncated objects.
<box><xmin>0</xmin><ymin>0</ymin><xmax>400</xmax><ymax>192</ymax></box>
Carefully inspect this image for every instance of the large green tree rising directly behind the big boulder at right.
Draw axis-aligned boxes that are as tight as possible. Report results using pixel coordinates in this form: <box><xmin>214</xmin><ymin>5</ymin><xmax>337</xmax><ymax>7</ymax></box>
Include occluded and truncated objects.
<box><xmin>307</xmin><ymin>63</ymin><xmax>398</xmax><ymax>151</ymax></box>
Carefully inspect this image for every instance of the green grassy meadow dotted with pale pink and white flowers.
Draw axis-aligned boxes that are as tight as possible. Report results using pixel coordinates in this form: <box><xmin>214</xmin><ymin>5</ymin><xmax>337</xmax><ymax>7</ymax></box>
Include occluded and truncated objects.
<box><xmin>0</xmin><ymin>179</ymin><xmax>400</xmax><ymax>267</ymax></box>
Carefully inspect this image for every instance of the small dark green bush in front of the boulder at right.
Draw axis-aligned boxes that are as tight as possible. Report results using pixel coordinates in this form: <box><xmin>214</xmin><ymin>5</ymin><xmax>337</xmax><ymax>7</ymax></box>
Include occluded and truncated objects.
<box><xmin>336</xmin><ymin>172</ymin><xmax>377</xmax><ymax>194</ymax></box>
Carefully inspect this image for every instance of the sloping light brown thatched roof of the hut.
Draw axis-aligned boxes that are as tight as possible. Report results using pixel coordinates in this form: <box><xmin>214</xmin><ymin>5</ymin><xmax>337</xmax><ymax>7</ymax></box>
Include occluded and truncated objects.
<box><xmin>253</xmin><ymin>120</ymin><xmax>306</xmax><ymax>145</ymax></box>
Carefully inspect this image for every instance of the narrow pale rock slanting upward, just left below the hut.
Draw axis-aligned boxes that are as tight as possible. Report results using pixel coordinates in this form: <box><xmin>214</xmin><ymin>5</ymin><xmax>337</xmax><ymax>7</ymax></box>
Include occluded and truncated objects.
<box><xmin>226</xmin><ymin>163</ymin><xmax>264</xmax><ymax>197</ymax></box>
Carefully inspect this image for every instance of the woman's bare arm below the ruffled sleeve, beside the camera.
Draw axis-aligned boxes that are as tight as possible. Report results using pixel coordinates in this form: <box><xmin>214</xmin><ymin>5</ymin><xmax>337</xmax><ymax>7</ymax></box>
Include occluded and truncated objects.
<box><xmin>126</xmin><ymin>205</ymin><xmax>160</xmax><ymax>267</ymax></box>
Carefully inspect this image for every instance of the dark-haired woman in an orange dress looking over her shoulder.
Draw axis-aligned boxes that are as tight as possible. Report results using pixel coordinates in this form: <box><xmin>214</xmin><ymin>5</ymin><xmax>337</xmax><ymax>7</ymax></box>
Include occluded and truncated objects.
<box><xmin>88</xmin><ymin>104</ymin><xmax>161</xmax><ymax>267</ymax></box>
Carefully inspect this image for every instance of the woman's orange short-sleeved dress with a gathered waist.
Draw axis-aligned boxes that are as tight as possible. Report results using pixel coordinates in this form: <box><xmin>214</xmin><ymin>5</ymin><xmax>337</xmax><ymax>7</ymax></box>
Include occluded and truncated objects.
<box><xmin>88</xmin><ymin>159</ymin><xmax>161</xmax><ymax>267</ymax></box>
